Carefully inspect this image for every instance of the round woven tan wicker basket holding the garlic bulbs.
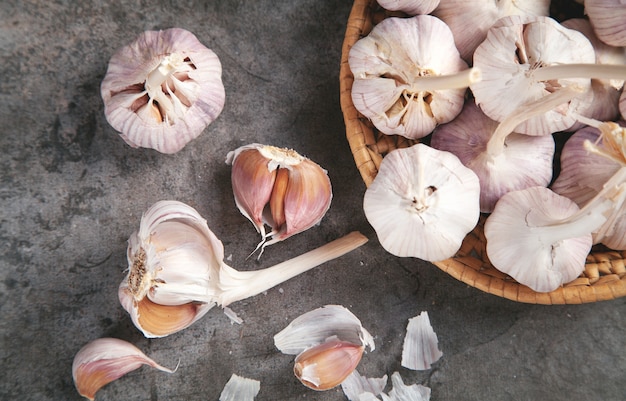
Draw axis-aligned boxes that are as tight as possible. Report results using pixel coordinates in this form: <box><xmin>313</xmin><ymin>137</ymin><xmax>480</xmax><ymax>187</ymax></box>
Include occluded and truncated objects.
<box><xmin>339</xmin><ymin>0</ymin><xmax>626</xmax><ymax>305</ymax></box>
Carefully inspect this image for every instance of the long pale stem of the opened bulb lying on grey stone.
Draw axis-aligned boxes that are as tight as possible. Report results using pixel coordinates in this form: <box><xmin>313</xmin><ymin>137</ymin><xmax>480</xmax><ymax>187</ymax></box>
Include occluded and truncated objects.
<box><xmin>217</xmin><ymin>231</ymin><xmax>367</xmax><ymax>306</ymax></box>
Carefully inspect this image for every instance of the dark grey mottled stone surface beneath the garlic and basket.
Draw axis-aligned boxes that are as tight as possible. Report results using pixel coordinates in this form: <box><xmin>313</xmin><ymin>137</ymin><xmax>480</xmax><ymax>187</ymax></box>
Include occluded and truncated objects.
<box><xmin>0</xmin><ymin>0</ymin><xmax>626</xmax><ymax>401</ymax></box>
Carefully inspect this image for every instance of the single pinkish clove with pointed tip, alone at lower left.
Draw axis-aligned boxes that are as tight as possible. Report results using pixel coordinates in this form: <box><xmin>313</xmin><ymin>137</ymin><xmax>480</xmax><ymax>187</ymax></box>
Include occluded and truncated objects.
<box><xmin>72</xmin><ymin>338</ymin><xmax>176</xmax><ymax>400</ymax></box>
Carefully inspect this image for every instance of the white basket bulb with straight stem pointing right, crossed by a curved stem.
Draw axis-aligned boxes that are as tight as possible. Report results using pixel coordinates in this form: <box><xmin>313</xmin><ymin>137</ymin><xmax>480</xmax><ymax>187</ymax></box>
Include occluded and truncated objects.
<box><xmin>470</xmin><ymin>17</ymin><xmax>596</xmax><ymax>135</ymax></box>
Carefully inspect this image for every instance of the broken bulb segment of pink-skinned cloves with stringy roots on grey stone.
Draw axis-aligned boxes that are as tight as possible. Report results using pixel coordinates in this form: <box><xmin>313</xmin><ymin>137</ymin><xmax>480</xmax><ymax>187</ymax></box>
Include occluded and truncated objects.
<box><xmin>226</xmin><ymin>143</ymin><xmax>332</xmax><ymax>250</ymax></box>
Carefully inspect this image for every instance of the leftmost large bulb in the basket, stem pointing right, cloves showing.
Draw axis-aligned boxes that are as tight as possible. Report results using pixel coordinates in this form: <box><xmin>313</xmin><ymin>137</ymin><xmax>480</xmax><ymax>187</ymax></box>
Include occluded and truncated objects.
<box><xmin>348</xmin><ymin>15</ymin><xmax>480</xmax><ymax>139</ymax></box>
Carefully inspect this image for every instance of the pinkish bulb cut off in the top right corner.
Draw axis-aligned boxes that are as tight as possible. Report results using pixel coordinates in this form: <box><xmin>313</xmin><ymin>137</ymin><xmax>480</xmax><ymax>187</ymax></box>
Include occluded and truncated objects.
<box><xmin>584</xmin><ymin>0</ymin><xmax>626</xmax><ymax>46</ymax></box>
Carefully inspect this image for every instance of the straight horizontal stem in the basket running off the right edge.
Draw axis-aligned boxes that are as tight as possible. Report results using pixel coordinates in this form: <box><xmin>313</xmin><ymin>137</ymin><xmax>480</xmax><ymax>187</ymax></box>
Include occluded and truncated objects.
<box><xmin>527</xmin><ymin>64</ymin><xmax>626</xmax><ymax>81</ymax></box>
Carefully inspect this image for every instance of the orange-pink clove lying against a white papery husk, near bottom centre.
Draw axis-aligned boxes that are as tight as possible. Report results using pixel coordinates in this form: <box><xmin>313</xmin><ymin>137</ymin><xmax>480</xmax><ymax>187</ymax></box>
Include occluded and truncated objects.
<box><xmin>293</xmin><ymin>338</ymin><xmax>365</xmax><ymax>391</ymax></box>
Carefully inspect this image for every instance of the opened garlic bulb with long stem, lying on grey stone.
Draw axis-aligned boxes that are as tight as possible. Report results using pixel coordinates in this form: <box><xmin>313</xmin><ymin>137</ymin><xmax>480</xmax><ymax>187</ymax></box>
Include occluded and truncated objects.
<box><xmin>118</xmin><ymin>201</ymin><xmax>367</xmax><ymax>337</ymax></box>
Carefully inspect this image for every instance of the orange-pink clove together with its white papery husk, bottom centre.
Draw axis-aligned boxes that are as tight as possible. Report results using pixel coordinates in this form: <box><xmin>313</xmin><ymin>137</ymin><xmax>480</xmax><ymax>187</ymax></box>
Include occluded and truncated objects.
<box><xmin>274</xmin><ymin>305</ymin><xmax>375</xmax><ymax>391</ymax></box>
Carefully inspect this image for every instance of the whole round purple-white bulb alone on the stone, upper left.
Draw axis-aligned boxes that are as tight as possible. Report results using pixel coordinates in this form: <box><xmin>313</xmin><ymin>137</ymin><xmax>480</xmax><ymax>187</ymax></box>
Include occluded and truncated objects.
<box><xmin>100</xmin><ymin>28</ymin><xmax>226</xmax><ymax>153</ymax></box>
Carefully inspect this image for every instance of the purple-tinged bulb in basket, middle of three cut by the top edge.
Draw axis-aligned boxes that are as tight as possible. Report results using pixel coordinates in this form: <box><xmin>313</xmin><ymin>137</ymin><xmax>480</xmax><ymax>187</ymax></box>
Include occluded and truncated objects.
<box><xmin>433</xmin><ymin>0</ymin><xmax>550</xmax><ymax>64</ymax></box>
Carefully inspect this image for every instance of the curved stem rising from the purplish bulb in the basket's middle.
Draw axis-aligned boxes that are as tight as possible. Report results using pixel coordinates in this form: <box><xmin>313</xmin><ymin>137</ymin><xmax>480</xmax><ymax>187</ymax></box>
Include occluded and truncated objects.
<box><xmin>486</xmin><ymin>85</ymin><xmax>583</xmax><ymax>158</ymax></box>
